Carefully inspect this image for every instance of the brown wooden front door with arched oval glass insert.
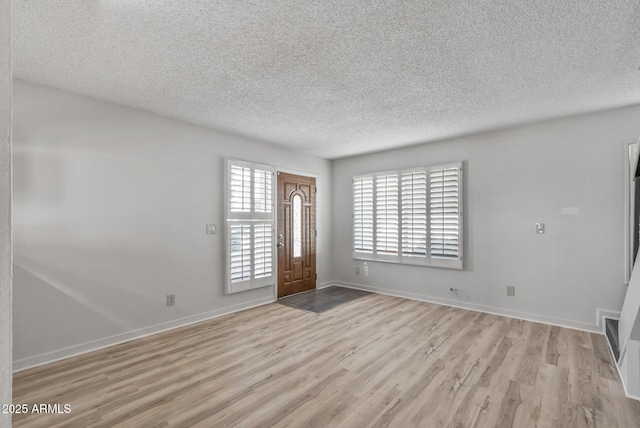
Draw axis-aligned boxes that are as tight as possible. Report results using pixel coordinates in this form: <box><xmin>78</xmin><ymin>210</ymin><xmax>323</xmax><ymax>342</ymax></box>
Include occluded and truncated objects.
<box><xmin>277</xmin><ymin>172</ymin><xmax>316</xmax><ymax>297</ymax></box>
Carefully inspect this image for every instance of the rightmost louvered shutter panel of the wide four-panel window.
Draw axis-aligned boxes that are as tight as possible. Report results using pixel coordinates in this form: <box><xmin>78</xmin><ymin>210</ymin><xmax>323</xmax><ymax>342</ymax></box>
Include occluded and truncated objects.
<box><xmin>428</xmin><ymin>164</ymin><xmax>462</xmax><ymax>267</ymax></box>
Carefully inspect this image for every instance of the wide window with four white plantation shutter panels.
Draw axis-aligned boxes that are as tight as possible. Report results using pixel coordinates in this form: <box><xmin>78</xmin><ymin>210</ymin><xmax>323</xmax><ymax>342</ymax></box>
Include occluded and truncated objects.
<box><xmin>353</xmin><ymin>162</ymin><xmax>463</xmax><ymax>269</ymax></box>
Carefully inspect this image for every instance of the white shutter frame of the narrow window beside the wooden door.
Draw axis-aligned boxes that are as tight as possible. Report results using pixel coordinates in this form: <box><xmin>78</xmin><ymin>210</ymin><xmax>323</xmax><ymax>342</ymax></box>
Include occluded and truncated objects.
<box><xmin>224</xmin><ymin>158</ymin><xmax>277</xmax><ymax>294</ymax></box>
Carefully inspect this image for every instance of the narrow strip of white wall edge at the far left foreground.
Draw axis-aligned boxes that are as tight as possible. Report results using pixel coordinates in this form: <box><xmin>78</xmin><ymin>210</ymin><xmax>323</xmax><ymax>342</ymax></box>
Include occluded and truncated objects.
<box><xmin>0</xmin><ymin>0</ymin><xmax>12</xmax><ymax>427</ymax></box>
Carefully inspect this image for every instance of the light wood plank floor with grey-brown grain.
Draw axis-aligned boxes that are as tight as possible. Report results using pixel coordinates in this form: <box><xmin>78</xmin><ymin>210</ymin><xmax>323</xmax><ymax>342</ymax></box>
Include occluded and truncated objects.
<box><xmin>13</xmin><ymin>294</ymin><xmax>640</xmax><ymax>428</ymax></box>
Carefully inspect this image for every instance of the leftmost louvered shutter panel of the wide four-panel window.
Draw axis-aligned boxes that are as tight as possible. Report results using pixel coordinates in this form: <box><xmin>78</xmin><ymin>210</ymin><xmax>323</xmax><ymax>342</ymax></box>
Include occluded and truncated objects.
<box><xmin>353</xmin><ymin>176</ymin><xmax>373</xmax><ymax>254</ymax></box>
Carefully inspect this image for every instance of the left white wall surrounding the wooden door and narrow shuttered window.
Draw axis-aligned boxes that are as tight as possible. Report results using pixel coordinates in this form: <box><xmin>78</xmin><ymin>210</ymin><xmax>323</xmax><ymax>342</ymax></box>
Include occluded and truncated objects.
<box><xmin>13</xmin><ymin>81</ymin><xmax>332</xmax><ymax>369</ymax></box>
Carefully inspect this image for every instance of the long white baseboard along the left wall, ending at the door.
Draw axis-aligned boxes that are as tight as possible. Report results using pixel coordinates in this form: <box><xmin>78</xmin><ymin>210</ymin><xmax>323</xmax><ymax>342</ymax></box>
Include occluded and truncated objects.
<box><xmin>13</xmin><ymin>297</ymin><xmax>275</xmax><ymax>373</ymax></box>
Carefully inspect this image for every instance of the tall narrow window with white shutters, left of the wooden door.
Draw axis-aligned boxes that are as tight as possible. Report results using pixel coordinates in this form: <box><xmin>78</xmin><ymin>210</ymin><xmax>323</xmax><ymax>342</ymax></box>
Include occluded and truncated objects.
<box><xmin>225</xmin><ymin>159</ymin><xmax>275</xmax><ymax>293</ymax></box>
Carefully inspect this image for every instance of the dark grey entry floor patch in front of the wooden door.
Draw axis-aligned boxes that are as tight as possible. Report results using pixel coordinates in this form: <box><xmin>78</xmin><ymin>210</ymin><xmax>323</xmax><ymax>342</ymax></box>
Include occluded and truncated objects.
<box><xmin>278</xmin><ymin>287</ymin><xmax>371</xmax><ymax>314</ymax></box>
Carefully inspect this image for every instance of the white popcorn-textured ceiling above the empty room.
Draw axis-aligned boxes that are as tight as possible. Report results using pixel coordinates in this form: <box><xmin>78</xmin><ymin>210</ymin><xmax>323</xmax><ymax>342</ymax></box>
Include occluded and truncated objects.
<box><xmin>12</xmin><ymin>0</ymin><xmax>640</xmax><ymax>158</ymax></box>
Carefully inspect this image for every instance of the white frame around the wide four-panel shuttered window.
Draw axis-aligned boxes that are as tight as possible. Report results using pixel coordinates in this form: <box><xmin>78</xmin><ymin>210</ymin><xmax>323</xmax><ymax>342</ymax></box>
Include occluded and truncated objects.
<box><xmin>351</xmin><ymin>161</ymin><xmax>464</xmax><ymax>270</ymax></box>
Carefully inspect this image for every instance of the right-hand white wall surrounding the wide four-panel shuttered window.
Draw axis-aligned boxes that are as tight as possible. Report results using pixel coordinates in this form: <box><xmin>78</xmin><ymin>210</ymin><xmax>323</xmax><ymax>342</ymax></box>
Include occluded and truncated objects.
<box><xmin>333</xmin><ymin>106</ymin><xmax>640</xmax><ymax>330</ymax></box>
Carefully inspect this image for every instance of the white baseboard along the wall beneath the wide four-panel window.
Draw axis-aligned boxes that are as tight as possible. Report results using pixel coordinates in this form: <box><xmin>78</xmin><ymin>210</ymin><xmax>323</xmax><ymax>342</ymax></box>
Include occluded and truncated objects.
<box><xmin>331</xmin><ymin>281</ymin><xmax>603</xmax><ymax>334</ymax></box>
